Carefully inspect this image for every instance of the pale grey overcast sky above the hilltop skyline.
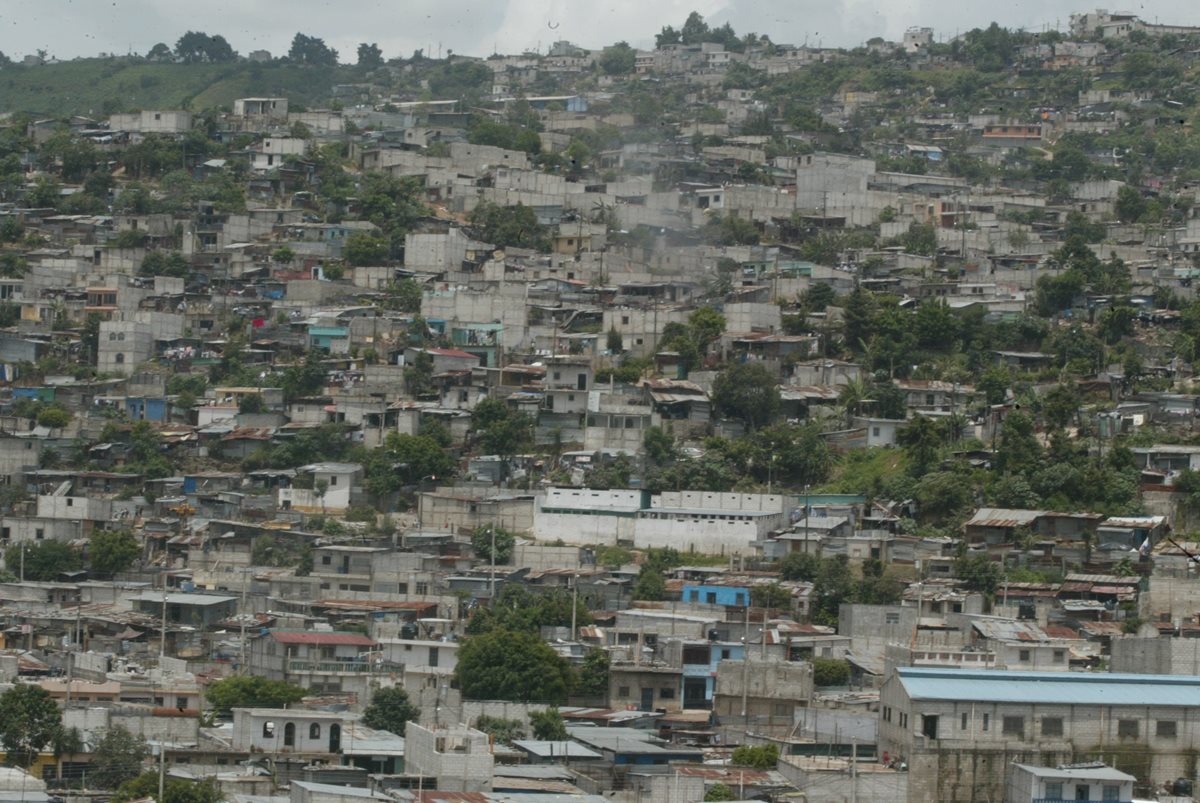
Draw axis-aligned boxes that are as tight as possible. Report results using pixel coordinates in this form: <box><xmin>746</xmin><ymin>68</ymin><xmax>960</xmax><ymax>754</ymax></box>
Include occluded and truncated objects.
<box><xmin>0</xmin><ymin>0</ymin><xmax>1200</xmax><ymax>62</ymax></box>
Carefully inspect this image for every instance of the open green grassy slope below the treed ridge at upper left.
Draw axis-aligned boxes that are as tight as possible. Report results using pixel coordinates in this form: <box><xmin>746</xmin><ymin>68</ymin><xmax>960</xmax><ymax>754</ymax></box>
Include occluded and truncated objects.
<box><xmin>0</xmin><ymin>59</ymin><xmax>360</xmax><ymax>116</ymax></box>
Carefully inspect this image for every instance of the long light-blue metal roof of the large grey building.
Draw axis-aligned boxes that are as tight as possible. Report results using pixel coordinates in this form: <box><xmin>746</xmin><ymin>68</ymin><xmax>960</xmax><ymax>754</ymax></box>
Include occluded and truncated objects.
<box><xmin>896</xmin><ymin>667</ymin><xmax>1200</xmax><ymax>707</ymax></box>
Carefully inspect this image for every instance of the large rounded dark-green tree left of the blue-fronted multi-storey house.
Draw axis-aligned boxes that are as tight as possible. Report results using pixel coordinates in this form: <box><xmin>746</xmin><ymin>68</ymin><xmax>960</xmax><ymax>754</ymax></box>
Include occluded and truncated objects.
<box><xmin>454</xmin><ymin>629</ymin><xmax>571</xmax><ymax>705</ymax></box>
